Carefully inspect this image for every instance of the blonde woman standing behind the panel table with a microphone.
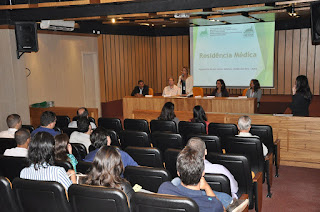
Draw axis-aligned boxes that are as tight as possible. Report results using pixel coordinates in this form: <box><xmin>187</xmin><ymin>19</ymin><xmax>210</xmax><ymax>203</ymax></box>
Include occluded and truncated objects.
<box><xmin>177</xmin><ymin>67</ymin><xmax>193</xmax><ymax>96</ymax></box>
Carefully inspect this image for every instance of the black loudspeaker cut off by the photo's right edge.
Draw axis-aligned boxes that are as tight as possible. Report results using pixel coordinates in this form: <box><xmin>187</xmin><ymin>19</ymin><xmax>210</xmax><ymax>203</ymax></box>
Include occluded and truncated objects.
<box><xmin>311</xmin><ymin>2</ymin><xmax>320</xmax><ymax>45</ymax></box>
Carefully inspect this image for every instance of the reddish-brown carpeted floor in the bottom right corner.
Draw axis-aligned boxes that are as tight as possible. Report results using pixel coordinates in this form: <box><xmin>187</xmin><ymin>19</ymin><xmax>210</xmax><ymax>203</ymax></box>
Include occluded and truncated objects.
<box><xmin>250</xmin><ymin>166</ymin><xmax>320</xmax><ymax>212</ymax></box>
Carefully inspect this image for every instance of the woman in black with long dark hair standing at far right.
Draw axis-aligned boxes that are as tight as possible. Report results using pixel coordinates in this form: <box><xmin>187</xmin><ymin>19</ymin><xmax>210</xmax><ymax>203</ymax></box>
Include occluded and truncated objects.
<box><xmin>290</xmin><ymin>75</ymin><xmax>312</xmax><ymax>116</ymax></box>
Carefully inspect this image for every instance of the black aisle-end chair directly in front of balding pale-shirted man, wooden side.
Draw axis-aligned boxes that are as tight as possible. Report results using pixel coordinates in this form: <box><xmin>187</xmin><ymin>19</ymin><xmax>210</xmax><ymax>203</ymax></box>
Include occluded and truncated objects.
<box><xmin>206</xmin><ymin>152</ymin><xmax>263</xmax><ymax>211</ymax></box>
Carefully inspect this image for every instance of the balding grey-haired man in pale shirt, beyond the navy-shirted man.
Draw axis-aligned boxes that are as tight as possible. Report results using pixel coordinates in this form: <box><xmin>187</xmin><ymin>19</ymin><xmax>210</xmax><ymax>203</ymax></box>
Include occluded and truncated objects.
<box><xmin>187</xmin><ymin>138</ymin><xmax>239</xmax><ymax>199</ymax></box>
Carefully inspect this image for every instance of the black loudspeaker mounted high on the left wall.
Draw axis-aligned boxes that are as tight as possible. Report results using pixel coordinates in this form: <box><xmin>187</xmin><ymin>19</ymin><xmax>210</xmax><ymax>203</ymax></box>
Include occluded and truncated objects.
<box><xmin>15</xmin><ymin>22</ymin><xmax>39</xmax><ymax>58</ymax></box>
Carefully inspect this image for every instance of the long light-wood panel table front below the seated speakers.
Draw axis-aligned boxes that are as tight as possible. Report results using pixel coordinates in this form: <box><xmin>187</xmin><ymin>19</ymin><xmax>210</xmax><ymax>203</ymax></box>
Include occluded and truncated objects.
<box><xmin>123</xmin><ymin>96</ymin><xmax>257</xmax><ymax>119</ymax></box>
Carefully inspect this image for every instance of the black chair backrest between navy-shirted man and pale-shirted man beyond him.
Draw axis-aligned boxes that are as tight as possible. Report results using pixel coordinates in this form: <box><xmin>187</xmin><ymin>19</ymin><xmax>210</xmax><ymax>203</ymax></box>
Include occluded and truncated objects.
<box><xmin>204</xmin><ymin>174</ymin><xmax>231</xmax><ymax>195</ymax></box>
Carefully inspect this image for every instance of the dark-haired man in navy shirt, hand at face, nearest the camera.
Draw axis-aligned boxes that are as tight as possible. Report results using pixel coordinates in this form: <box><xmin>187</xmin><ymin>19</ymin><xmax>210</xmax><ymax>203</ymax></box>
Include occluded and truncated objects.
<box><xmin>158</xmin><ymin>146</ymin><xmax>249</xmax><ymax>212</ymax></box>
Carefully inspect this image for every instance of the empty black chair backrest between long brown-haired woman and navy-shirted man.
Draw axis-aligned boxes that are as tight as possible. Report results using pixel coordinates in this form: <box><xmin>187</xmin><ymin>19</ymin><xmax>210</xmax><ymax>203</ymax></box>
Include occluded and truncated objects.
<box><xmin>124</xmin><ymin>166</ymin><xmax>171</xmax><ymax>192</ymax></box>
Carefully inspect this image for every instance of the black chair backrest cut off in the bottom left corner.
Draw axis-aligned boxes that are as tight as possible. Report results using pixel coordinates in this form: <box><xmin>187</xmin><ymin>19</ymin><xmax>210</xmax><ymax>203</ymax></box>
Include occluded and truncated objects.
<box><xmin>0</xmin><ymin>176</ymin><xmax>20</xmax><ymax>212</ymax></box>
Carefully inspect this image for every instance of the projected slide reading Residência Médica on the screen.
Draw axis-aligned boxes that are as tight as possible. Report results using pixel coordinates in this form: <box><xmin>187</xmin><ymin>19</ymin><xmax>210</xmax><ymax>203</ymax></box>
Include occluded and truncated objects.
<box><xmin>190</xmin><ymin>22</ymin><xmax>275</xmax><ymax>87</ymax></box>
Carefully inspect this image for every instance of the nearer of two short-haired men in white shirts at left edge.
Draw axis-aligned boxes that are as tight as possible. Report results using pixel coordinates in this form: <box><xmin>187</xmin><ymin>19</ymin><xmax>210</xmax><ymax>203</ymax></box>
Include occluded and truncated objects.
<box><xmin>3</xmin><ymin>128</ymin><xmax>31</xmax><ymax>157</ymax></box>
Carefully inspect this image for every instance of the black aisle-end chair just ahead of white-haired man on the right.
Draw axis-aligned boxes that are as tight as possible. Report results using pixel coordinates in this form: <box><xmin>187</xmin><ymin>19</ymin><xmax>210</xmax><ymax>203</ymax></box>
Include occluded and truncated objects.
<box><xmin>250</xmin><ymin>124</ymin><xmax>280</xmax><ymax>177</ymax></box>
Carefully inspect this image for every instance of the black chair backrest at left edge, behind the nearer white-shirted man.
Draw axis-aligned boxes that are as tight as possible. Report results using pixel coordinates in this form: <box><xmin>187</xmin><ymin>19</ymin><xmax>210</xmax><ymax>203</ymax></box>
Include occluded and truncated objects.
<box><xmin>0</xmin><ymin>156</ymin><xmax>29</xmax><ymax>181</ymax></box>
